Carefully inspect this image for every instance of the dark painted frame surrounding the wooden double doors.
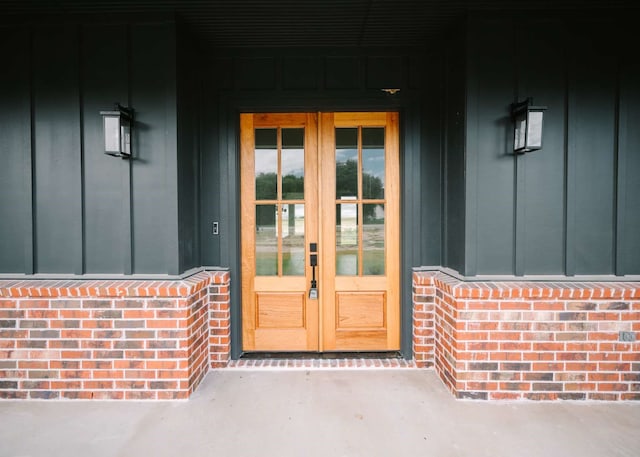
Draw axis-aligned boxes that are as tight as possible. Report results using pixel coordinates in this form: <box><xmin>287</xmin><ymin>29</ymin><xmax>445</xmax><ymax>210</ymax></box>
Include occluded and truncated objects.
<box><xmin>218</xmin><ymin>92</ymin><xmax>422</xmax><ymax>360</ymax></box>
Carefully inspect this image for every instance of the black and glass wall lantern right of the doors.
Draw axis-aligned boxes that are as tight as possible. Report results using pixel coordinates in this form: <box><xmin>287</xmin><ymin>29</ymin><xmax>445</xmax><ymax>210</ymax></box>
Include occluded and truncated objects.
<box><xmin>511</xmin><ymin>97</ymin><xmax>547</xmax><ymax>154</ymax></box>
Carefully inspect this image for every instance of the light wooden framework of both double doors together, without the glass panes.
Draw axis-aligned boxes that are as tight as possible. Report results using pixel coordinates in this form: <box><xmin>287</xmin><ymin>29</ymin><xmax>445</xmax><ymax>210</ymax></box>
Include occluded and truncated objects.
<box><xmin>240</xmin><ymin>111</ymin><xmax>400</xmax><ymax>352</ymax></box>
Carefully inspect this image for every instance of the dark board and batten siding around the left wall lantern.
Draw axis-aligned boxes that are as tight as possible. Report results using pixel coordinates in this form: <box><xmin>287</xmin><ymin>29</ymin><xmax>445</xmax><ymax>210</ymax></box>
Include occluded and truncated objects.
<box><xmin>0</xmin><ymin>21</ymin><xmax>199</xmax><ymax>275</ymax></box>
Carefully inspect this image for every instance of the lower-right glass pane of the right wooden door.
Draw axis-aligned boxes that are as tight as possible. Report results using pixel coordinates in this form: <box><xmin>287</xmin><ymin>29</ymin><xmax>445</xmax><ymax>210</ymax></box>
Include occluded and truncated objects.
<box><xmin>362</xmin><ymin>204</ymin><xmax>385</xmax><ymax>275</ymax></box>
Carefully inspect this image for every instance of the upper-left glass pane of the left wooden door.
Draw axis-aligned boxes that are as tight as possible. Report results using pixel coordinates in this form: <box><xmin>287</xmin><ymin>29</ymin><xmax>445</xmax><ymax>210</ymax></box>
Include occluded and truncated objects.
<box><xmin>255</xmin><ymin>129</ymin><xmax>278</xmax><ymax>200</ymax></box>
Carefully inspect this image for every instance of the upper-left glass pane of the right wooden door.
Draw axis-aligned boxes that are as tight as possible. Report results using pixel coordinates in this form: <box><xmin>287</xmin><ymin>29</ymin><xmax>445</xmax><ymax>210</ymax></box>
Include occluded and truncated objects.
<box><xmin>336</xmin><ymin>128</ymin><xmax>358</xmax><ymax>198</ymax></box>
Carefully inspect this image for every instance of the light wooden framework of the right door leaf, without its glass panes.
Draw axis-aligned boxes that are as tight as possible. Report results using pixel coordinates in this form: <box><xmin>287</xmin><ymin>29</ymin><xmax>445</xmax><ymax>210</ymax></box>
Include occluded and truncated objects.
<box><xmin>320</xmin><ymin>113</ymin><xmax>400</xmax><ymax>351</ymax></box>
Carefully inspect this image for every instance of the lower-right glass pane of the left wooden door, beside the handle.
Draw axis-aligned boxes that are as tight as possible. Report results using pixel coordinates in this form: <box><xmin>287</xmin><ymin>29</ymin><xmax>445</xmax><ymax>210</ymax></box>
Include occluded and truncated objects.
<box><xmin>282</xmin><ymin>204</ymin><xmax>305</xmax><ymax>276</ymax></box>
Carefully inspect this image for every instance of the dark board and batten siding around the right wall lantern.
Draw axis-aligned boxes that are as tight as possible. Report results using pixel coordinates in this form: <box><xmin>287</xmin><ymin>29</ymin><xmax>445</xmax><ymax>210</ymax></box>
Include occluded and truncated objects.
<box><xmin>456</xmin><ymin>15</ymin><xmax>640</xmax><ymax>277</ymax></box>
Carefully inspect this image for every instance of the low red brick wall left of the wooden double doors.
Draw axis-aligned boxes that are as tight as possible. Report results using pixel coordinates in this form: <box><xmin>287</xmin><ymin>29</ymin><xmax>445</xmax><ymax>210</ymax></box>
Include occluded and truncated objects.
<box><xmin>0</xmin><ymin>272</ymin><xmax>229</xmax><ymax>400</ymax></box>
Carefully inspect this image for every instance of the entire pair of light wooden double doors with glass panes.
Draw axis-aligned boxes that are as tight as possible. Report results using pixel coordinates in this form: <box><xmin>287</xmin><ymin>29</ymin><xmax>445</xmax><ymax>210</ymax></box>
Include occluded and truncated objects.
<box><xmin>240</xmin><ymin>112</ymin><xmax>400</xmax><ymax>352</ymax></box>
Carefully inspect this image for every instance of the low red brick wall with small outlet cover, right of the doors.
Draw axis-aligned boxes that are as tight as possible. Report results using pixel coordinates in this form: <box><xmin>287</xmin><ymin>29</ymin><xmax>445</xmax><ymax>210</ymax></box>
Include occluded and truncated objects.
<box><xmin>414</xmin><ymin>272</ymin><xmax>640</xmax><ymax>400</ymax></box>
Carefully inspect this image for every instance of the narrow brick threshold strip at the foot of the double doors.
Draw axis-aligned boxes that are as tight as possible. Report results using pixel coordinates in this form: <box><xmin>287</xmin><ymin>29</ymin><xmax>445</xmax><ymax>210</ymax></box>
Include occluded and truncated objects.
<box><xmin>223</xmin><ymin>352</ymin><xmax>417</xmax><ymax>370</ymax></box>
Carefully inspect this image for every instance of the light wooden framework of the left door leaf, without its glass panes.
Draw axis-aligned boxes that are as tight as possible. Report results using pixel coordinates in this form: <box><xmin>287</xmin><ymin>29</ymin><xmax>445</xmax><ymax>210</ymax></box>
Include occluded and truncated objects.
<box><xmin>240</xmin><ymin>113</ymin><xmax>319</xmax><ymax>351</ymax></box>
